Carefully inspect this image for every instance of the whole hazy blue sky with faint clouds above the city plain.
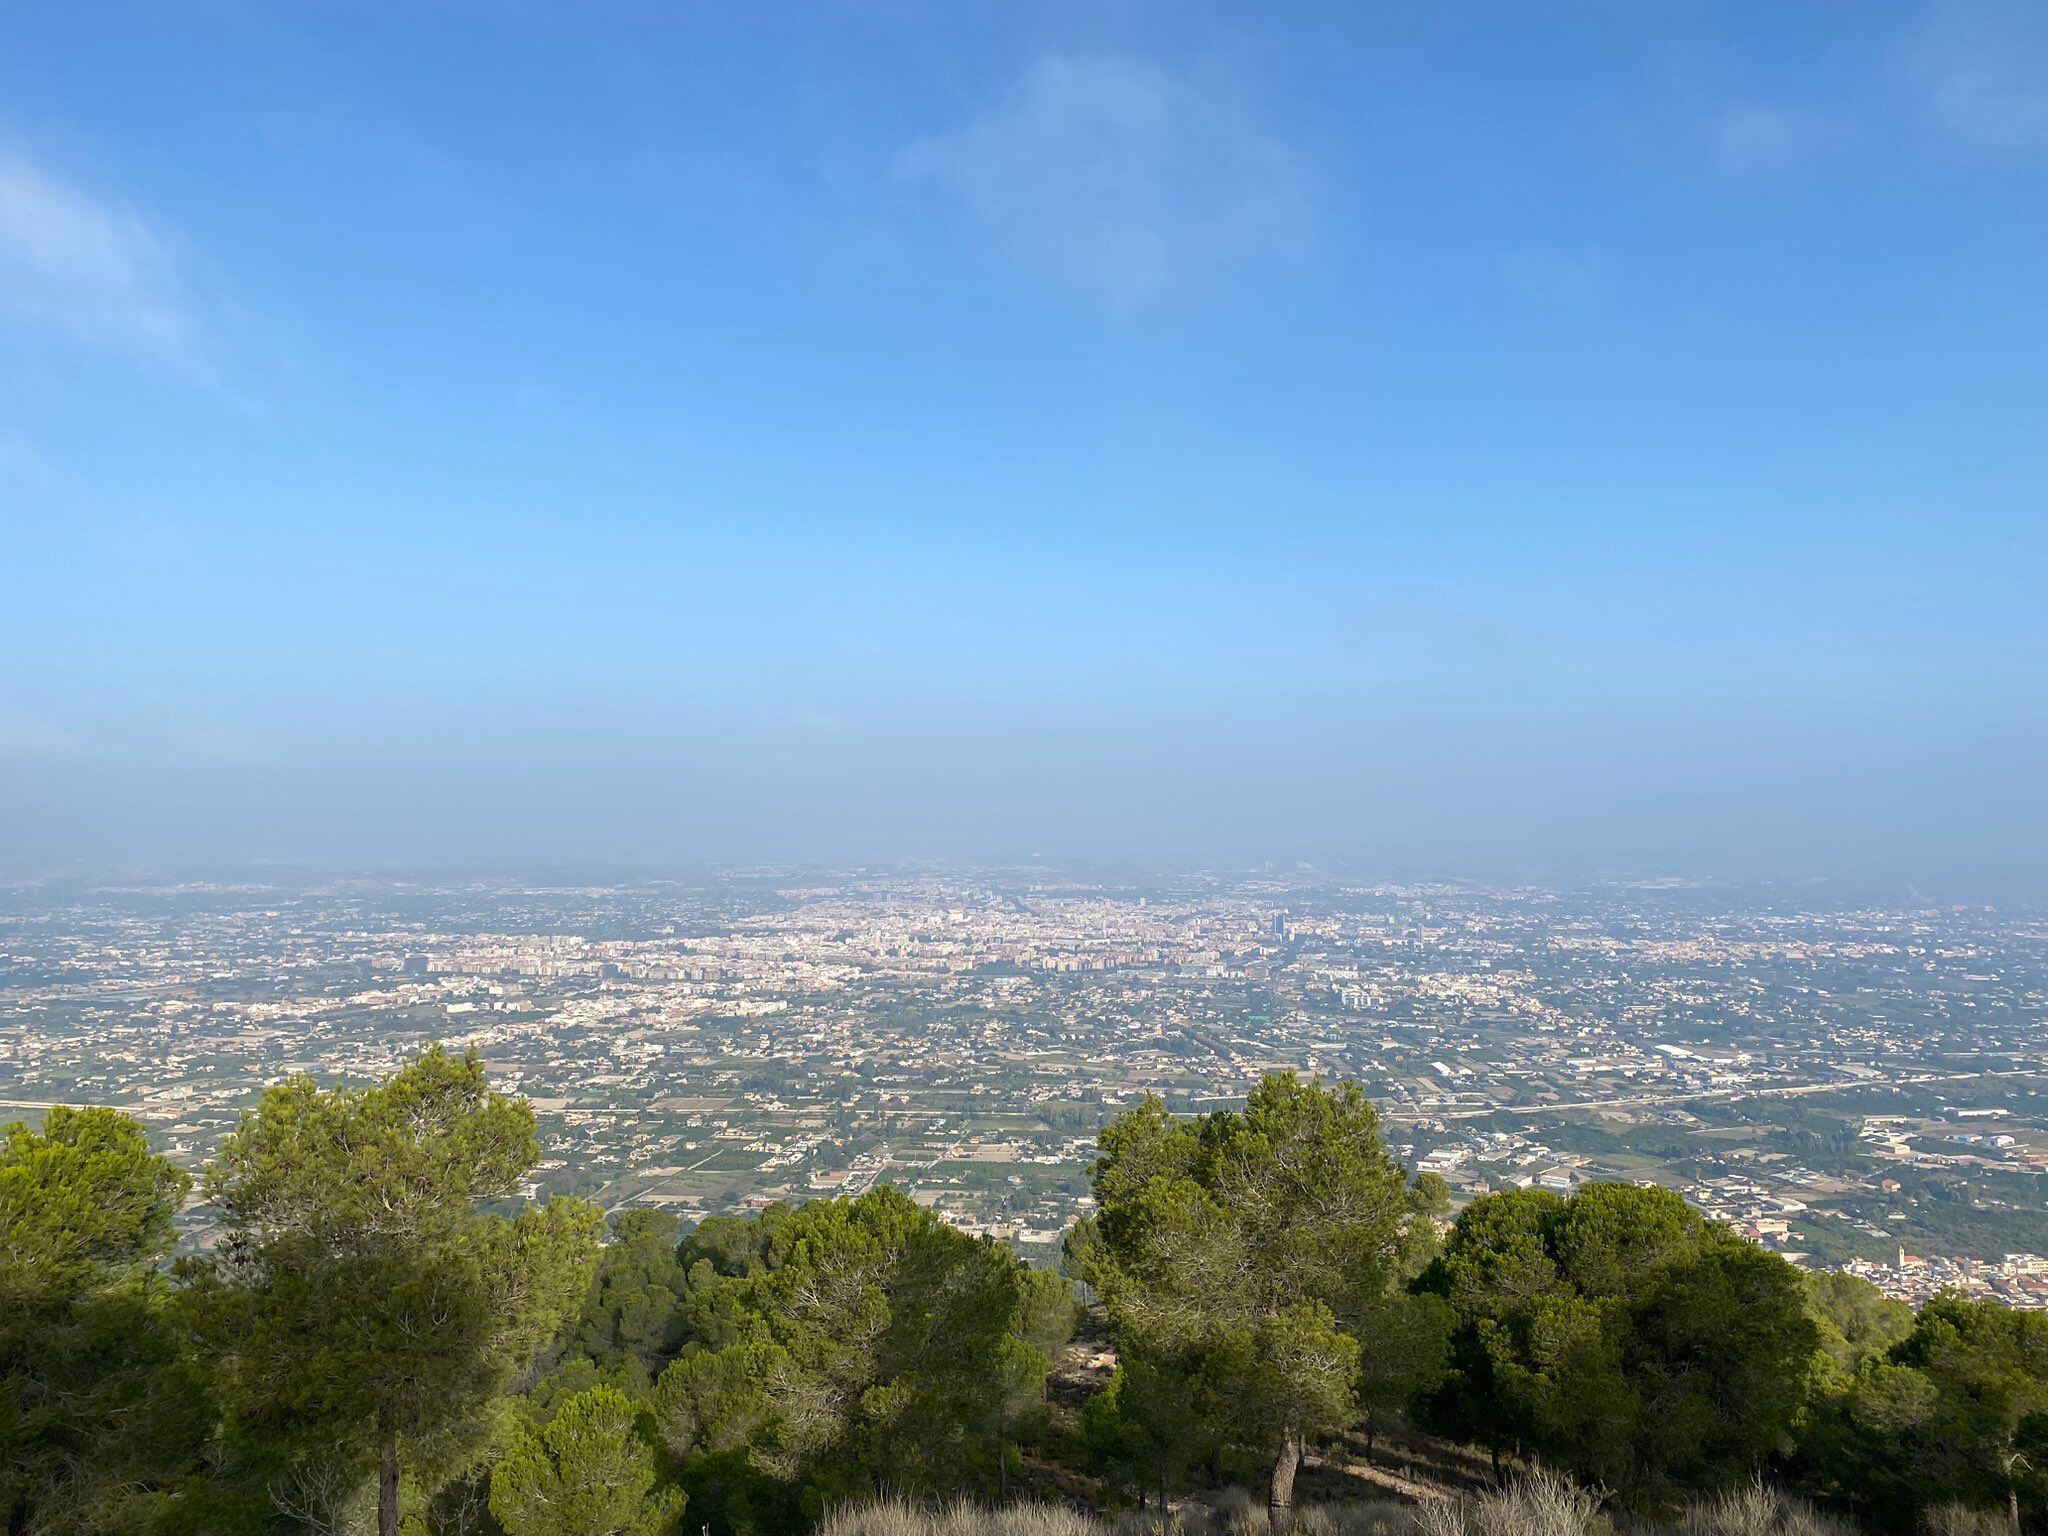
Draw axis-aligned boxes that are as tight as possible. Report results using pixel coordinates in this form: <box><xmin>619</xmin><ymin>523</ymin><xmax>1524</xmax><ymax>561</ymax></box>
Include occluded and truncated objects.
<box><xmin>0</xmin><ymin>0</ymin><xmax>2048</xmax><ymax>879</ymax></box>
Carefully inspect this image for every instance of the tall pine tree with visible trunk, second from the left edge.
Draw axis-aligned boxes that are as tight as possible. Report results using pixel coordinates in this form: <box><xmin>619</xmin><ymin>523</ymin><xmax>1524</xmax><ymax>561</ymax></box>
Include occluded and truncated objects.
<box><xmin>193</xmin><ymin>1047</ymin><xmax>602</xmax><ymax>1536</ymax></box>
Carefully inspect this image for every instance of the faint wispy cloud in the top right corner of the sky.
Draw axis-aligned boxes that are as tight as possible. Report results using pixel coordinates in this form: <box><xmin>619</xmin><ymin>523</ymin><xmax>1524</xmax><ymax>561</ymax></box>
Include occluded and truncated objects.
<box><xmin>1913</xmin><ymin>0</ymin><xmax>2048</xmax><ymax>150</ymax></box>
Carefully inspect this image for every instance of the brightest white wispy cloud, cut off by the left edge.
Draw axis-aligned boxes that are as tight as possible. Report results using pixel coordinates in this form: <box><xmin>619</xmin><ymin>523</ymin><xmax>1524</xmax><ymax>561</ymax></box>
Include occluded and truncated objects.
<box><xmin>0</xmin><ymin>147</ymin><xmax>209</xmax><ymax>375</ymax></box>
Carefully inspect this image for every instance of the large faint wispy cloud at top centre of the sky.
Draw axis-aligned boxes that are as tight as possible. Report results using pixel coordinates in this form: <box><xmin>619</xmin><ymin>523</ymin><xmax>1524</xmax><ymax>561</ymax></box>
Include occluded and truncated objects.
<box><xmin>897</xmin><ymin>53</ymin><xmax>1311</xmax><ymax>305</ymax></box>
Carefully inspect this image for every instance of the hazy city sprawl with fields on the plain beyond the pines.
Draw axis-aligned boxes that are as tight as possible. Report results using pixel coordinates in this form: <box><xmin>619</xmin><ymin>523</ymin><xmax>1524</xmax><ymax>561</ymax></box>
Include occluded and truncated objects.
<box><xmin>0</xmin><ymin>868</ymin><xmax>2048</xmax><ymax>1305</ymax></box>
